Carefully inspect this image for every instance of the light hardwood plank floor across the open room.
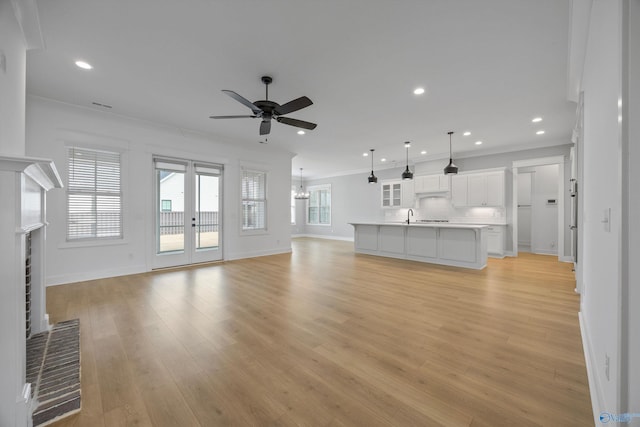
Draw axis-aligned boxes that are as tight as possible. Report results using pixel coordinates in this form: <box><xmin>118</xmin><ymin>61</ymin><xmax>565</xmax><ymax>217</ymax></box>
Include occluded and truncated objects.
<box><xmin>47</xmin><ymin>239</ymin><xmax>593</xmax><ymax>427</ymax></box>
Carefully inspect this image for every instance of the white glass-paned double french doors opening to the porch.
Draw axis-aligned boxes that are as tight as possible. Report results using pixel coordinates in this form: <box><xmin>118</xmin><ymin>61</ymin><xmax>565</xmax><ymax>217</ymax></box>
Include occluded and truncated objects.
<box><xmin>153</xmin><ymin>158</ymin><xmax>223</xmax><ymax>268</ymax></box>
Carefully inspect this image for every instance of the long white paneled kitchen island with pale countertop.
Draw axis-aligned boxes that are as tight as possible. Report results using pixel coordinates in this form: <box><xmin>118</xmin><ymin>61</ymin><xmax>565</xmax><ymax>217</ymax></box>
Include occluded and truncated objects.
<box><xmin>350</xmin><ymin>222</ymin><xmax>487</xmax><ymax>270</ymax></box>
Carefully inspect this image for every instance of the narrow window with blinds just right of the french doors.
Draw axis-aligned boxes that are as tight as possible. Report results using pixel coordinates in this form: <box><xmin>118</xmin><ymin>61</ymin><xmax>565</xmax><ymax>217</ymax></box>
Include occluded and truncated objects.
<box><xmin>242</xmin><ymin>170</ymin><xmax>267</xmax><ymax>230</ymax></box>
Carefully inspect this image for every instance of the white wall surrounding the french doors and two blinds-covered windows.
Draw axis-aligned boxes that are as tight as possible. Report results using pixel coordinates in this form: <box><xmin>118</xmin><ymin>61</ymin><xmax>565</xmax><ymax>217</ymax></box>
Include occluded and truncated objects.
<box><xmin>26</xmin><ymin>96</ymin><xmax>291</xmax><ymax>284</ymax></box>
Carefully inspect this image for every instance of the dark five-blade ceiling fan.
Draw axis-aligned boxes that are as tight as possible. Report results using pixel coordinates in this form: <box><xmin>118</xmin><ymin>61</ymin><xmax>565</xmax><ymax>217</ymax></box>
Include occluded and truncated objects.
<box><xmin>209</xmin><ymin>76</ymin><xmax>317</xmax><ymax>135</ymax></box>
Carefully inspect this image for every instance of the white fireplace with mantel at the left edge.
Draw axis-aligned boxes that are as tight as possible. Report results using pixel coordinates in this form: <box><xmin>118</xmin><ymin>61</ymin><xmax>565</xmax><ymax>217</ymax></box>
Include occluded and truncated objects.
<box><xmin>0</xmin><ymin>156</ymin><xmax>62</xmax><ymax>427</ymax></box>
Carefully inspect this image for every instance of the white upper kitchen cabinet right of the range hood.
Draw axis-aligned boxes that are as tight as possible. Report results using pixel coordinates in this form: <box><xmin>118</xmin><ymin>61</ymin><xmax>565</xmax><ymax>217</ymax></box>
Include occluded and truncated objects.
<box><xmin>451</xmin><ymin>171</ymin><xmax>505</xmax><ymax>207</ymax></box>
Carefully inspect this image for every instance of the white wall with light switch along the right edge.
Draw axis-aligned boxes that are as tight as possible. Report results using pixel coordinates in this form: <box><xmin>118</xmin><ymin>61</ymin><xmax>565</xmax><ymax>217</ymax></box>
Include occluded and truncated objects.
<box><xmin>578</xmin><ymin>0</ymin><xmax>640</xmax><ymax>425</ymax></box>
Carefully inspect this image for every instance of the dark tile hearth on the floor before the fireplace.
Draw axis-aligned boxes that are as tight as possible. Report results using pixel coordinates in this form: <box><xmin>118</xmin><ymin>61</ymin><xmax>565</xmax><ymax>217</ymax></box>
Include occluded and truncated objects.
<box><xmin>27</xmin><ymin>319</ymin><xmax>81</xmax><ymax>426</ymax></box>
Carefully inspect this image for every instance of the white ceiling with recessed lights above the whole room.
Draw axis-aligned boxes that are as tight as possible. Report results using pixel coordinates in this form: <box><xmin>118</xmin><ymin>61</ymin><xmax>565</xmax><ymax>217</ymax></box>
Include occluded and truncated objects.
<box><xmin>27</xmin><ymin>0</ymin><xmax>575</xmax><ymax>177</ymax></box>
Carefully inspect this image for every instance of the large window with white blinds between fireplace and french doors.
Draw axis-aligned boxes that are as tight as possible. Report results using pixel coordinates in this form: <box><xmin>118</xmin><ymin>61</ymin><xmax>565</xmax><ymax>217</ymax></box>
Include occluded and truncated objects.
<box><xmin>67</xmin><ymin>147</ymin><xmax>122</xmax><ymax>241</ymax></box>
